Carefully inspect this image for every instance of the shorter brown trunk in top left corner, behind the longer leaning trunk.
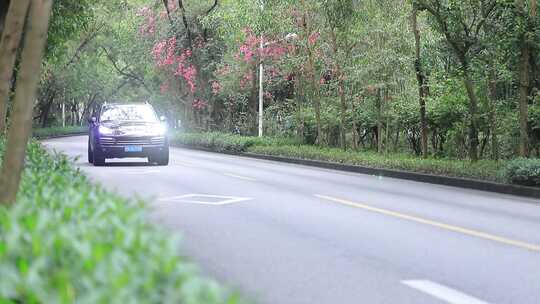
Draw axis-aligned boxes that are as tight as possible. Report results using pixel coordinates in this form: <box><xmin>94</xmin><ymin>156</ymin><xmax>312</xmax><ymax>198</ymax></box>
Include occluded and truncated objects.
<box><xmin>0</xmin><ymin>0</ymin><xmax>30</xmax><ymax>135</ymax></box>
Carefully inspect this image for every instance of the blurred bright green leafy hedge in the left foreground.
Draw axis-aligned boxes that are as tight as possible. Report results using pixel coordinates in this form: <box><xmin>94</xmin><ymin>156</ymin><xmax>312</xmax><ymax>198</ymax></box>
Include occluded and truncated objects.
<box><xmin>0</xmin><ymin>138</ymin><xmax>238</xmax><ymax>304</ymax></box>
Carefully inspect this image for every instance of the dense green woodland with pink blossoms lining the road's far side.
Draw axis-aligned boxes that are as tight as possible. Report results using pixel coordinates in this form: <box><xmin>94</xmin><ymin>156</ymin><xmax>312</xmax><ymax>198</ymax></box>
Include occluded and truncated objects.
<box><xmin>5</xmin><ymin>0</ymin><xmax>540</xmax><ymax>164</ymax></box>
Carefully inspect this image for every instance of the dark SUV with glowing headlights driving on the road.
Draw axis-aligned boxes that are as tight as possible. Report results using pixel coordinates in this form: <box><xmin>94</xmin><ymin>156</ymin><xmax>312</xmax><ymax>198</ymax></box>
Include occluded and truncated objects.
<box><xmin>88</xmin><ymin>104</ymin><xmax>169</xmax><ymax>166</ymax></box>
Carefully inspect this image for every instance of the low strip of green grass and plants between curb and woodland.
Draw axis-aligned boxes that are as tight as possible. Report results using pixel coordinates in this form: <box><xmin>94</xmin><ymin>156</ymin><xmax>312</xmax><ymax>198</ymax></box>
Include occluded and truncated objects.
<box><xmin>171</xmin><ymin>132</ymin><xmax>540</xmax><ymax>186</ymax></box>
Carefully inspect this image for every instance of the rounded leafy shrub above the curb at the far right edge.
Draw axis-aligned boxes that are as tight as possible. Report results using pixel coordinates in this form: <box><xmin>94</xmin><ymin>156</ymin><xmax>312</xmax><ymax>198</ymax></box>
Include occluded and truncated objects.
<box><xmin>503</xmin><ymin>158</ymin><xmax>540</xmax><ymax>187</ymax></box>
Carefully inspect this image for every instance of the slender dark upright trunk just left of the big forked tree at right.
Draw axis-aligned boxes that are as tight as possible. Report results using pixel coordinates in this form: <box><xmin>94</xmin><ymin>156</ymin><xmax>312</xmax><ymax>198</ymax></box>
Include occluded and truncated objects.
<box><xmin>412</xmin><ymin>6</ymin><xmax>428</xmax><ymax>158</ymax></box>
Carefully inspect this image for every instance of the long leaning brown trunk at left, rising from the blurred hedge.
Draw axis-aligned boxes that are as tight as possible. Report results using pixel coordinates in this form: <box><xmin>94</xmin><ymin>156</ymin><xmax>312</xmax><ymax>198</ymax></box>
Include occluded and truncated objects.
<box><xmin>0</xmin><ymin>0</ymin><xmax>52</xmax><ymax>204</ymax></box>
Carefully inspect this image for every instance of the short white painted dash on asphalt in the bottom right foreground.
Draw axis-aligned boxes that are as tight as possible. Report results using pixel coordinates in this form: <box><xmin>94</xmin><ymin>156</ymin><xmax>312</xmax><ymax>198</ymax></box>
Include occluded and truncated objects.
<box><xmin>401</xmin><ymin>280</ymin><xmax>489</xmax><ymax>304</ymax></box>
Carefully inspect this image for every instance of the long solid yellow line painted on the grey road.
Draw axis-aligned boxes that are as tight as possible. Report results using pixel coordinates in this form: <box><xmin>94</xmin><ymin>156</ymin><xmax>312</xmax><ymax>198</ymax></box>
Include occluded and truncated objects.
<box><xmin>315</xmin><ymin>194</ymin><xmax>540</xmax><ymax>252</ymax></box>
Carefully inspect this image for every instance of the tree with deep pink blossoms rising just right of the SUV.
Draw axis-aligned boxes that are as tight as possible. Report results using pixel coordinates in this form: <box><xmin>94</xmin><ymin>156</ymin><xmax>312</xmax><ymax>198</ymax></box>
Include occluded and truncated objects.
<box><xmin>138</xmin><ymin>0</ymin><xmax>220</xmax><ymax>128</ymax></box>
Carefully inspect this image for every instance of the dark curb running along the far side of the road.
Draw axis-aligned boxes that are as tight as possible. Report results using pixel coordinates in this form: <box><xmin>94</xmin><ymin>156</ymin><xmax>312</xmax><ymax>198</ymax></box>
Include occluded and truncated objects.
<box><xmin>171</xmin><ymin>145</ymin><xmax>540</xmax><ymax>199</ymax></box>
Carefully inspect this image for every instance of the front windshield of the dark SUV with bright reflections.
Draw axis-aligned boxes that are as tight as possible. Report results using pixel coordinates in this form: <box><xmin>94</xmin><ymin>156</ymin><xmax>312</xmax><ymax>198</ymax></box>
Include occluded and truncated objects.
<box><xmin>101</xmin><ymin>105</ymin><xmax>158</xmax><ymax>122</ymax></box>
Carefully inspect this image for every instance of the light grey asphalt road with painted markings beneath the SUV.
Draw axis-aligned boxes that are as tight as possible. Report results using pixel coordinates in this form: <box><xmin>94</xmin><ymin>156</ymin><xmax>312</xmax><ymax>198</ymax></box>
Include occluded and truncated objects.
<box><xmin>45</xmin><ymin>136</ymin><xmax>540</xmax><ymax>304</ymax></box>
